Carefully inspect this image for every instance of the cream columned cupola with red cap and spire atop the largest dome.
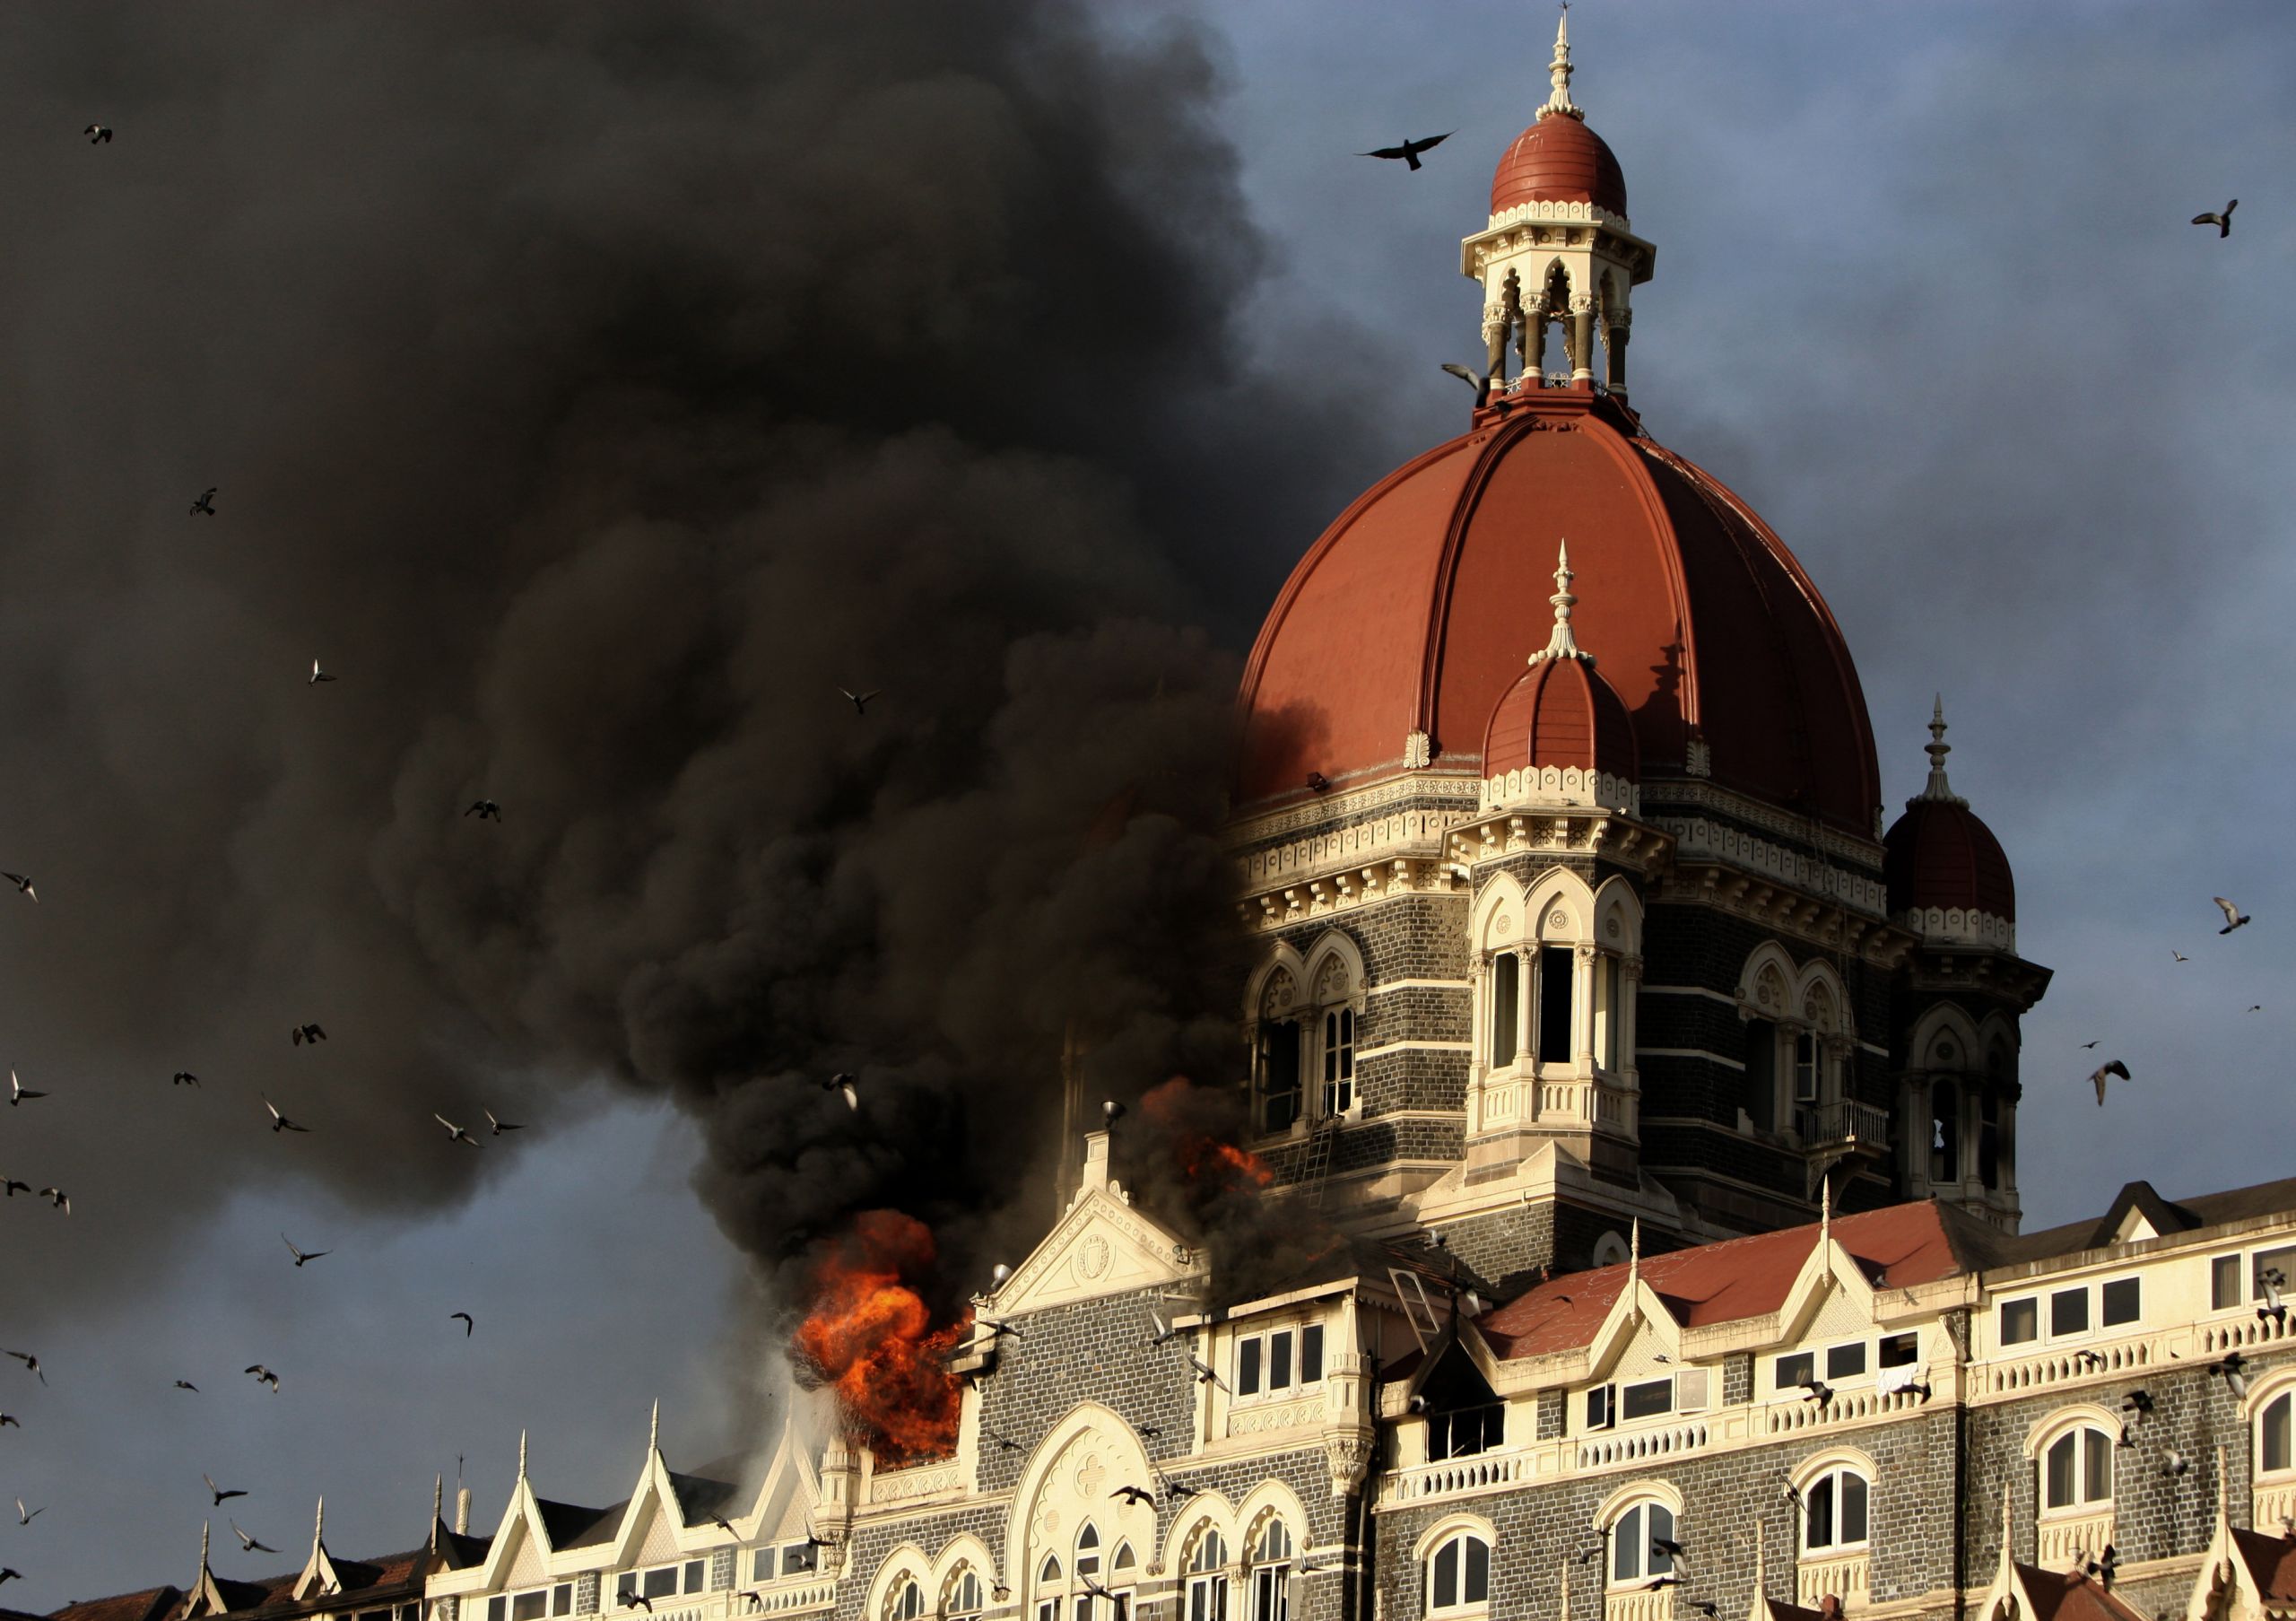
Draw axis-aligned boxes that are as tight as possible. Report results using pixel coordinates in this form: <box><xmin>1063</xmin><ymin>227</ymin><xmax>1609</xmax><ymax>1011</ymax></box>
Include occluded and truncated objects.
<box><xmin>1458</xmin><ymin>9</ymin><xmax>1656</xmax><ymax>393</ymax></box>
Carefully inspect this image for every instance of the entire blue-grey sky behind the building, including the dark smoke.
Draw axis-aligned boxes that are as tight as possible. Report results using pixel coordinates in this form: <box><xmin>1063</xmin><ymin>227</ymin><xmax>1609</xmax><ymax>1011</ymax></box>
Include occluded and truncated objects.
<box><xmin>0</xmin><ymin>0</ymin><xmax>2296</xmax><ymax>1608</ymax></box>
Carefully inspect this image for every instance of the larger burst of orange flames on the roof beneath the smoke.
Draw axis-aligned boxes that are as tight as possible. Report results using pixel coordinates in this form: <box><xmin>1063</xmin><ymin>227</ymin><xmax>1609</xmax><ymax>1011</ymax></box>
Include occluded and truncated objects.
<box><xmin>796</xmin><ymin>1210</ymin><xmax>971</xmax><ymax>1462</ymax></box>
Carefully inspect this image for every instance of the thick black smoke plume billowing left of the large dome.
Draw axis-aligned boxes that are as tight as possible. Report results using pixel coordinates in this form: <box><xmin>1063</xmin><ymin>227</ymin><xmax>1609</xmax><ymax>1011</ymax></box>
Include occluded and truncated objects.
<box><xmin>0</xmin><ymin>0</ymin><xmax>1361</xmax><ymax>1340</ymax></box>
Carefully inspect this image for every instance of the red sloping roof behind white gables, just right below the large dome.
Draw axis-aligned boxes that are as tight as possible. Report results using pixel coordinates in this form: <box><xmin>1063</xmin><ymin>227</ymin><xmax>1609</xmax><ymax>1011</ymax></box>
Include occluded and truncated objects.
<box><xmin>1474</xmin><ymin>1198</ymin><xmax>1975</xmax><ymax>1359</ymax></box>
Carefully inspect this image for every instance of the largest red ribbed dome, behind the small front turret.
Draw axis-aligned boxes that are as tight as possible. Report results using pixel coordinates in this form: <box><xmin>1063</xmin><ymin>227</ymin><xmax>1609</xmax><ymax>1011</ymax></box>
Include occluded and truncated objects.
<box><xmin>1235</xmin><ymin>388</ymin><xmax>1881</xmax><ymax>838</ymax></box>
